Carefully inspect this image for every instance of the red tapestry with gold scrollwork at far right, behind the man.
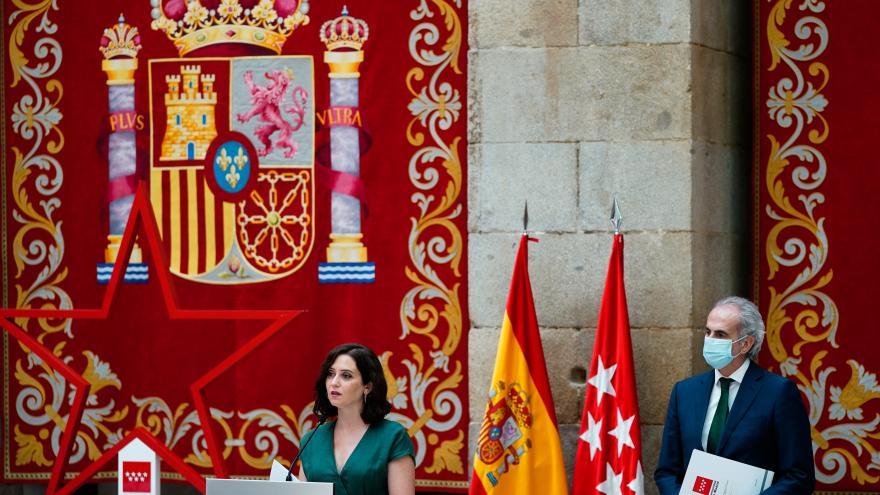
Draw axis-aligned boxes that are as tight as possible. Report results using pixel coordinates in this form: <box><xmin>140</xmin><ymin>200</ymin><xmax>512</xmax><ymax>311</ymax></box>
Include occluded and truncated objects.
<box><xmin>754</xmin><ymin>0</ymin><xmax>880</xmax><ymax>491</ymax></box>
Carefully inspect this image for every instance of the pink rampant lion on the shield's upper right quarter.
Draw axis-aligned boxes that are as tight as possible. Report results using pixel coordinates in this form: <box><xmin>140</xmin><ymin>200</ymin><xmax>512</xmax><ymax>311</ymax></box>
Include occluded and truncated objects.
<box><xmin>236</xmin><ymin>70</ymin><xmax>308</xmax><ymax>158</ymax></box>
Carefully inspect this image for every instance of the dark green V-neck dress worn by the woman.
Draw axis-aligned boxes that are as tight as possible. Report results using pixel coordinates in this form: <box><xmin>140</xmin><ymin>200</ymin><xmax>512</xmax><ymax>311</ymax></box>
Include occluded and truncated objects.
<box><xmin>300</xmin><ymin>419</ymin><xmax>414</xmax><ymax>495</ymax></box>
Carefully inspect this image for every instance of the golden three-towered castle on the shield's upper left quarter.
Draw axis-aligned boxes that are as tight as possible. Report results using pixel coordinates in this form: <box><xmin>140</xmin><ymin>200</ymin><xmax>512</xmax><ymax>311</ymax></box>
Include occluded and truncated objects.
<box><xmin>159</xmin><ymin>65</ymin><xmax>217</xmax><ymax>160</ymax></box>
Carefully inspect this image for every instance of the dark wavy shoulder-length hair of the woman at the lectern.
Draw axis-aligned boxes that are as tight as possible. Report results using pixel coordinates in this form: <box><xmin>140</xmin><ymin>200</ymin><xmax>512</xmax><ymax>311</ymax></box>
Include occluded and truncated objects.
<box><xmin>312</xmin><ymin>344</ymin><xmax>391</xmax><ymax>424</ymax></box>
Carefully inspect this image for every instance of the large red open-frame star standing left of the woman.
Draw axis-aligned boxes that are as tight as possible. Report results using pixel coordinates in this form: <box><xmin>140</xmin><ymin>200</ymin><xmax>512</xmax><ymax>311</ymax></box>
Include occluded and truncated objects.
<box><xmin>0</xmin><ymin>182</ymin><xmax>302</xmax><ymax>495</ymax></box>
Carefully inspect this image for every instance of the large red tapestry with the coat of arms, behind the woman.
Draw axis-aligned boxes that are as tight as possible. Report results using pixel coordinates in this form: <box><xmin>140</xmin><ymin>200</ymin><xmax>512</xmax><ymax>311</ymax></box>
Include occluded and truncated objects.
<box><xmin>0</xmin><ymin>0</ymin><xmax>468</xmax><ymax>490</ymax></box>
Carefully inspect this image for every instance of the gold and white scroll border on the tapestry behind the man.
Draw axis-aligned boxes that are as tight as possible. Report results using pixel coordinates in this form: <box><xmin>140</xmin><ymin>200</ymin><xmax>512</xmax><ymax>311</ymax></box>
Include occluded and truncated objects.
<box><xmin>755</xmin><ymin>0</ymin><xmax>880</xmax><ymax>493</ymax></box>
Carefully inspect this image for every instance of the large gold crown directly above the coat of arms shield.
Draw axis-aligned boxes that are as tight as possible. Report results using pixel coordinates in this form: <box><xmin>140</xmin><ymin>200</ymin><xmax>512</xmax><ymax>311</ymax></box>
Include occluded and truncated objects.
<box><xmin>150</xmin><ymin>0</ymin><xmax>309</xmax><ymax>56</ymax></box>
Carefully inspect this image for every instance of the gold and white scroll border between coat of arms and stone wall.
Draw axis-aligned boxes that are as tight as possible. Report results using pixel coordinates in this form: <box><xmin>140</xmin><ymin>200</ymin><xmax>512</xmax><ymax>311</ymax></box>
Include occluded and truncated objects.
<box><xmin>398</xmin><ymin>0</ymin><xmax>464</xmax><ymax>486</ymax></box>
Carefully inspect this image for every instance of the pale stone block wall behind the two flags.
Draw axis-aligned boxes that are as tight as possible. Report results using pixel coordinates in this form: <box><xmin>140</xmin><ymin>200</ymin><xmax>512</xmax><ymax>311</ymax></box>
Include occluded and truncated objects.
<box><xmin>468</xmin><ymin>0</ymin><xmax>752</xmax><ymax>493</ymax></box>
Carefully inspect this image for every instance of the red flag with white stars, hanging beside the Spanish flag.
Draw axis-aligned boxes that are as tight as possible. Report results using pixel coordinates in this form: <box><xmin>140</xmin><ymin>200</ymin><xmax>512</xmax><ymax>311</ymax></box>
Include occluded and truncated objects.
<box><xmin>572</xmin><ymin>234</ymin><xmax>645</xmax><ymax>495</ymax></box>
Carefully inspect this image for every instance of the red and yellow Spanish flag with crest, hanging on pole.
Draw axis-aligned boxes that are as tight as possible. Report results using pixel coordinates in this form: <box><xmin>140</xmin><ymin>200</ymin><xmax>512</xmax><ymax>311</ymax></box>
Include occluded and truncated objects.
<box><xmin>470</xmin><ymin>234</ymin><xmax>568</xmax><ymax>495</ymax></box>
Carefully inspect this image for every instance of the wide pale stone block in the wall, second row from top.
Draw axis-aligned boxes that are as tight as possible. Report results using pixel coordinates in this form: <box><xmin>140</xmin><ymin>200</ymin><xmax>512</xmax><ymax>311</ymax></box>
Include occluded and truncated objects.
<box><xmin>469</xmin><ymin>45</ymin><xmax>692</xmax><ymax>143</ymax></box>
